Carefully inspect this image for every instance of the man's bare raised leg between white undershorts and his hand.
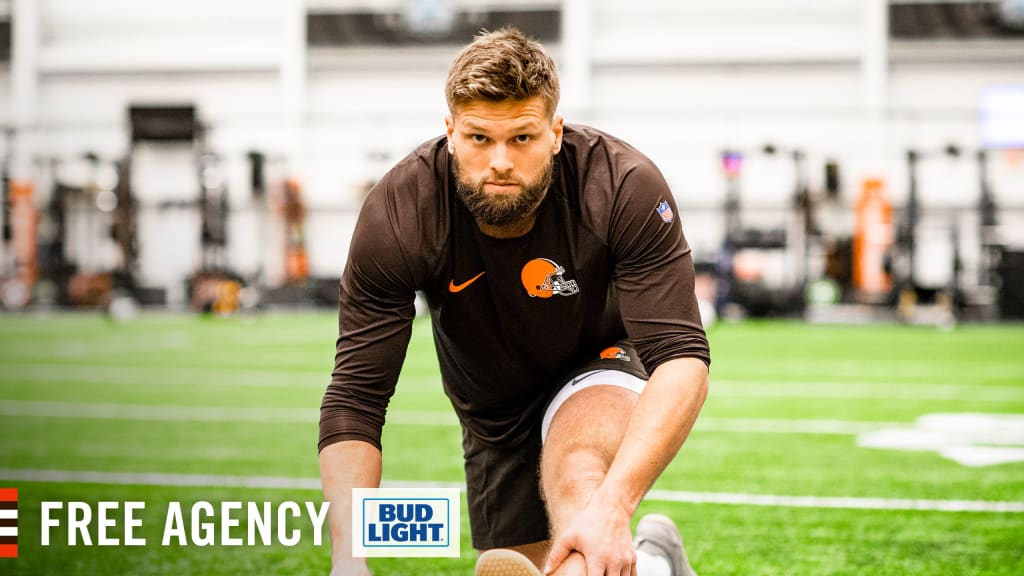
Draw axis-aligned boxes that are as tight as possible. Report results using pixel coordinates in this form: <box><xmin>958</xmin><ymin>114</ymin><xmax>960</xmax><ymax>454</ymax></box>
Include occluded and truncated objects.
<box><xmin>541</xmin><ymin>385</ymin><xmax>639</xmax><ymax>576</ymax></box>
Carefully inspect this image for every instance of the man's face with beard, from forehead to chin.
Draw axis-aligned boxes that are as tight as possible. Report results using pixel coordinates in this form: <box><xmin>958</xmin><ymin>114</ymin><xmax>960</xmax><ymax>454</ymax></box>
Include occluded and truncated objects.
<box><xmin>444</xmin><ymin>97</ymin><xmax>563</xmax><ymax>227</ymax></box>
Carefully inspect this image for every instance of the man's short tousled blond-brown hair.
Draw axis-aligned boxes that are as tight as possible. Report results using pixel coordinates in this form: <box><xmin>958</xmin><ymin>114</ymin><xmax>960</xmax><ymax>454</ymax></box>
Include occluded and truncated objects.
<box><xmin>444</xmin><ymin>28</ymin><xmax>559</xmax><ymax>115</ymax></box>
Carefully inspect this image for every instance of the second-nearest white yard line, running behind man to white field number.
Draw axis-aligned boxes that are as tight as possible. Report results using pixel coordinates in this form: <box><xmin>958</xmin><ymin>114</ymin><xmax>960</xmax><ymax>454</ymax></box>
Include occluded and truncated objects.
<box><xmin>0</xmin><ymin>401</ymin><xmax>908</xmax><ymax>436</ymax></box>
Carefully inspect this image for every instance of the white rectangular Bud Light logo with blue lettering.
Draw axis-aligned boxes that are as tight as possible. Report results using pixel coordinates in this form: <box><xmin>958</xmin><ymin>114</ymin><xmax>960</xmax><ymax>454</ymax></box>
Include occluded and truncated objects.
<box><xmin>352</xmin><ymin>488</ymin><xmax>461</xmax><ymax>558</ymax></box>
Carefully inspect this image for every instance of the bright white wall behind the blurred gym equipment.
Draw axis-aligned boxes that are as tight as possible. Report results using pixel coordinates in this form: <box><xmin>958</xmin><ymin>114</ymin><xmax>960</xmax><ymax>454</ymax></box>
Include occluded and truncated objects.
<box><xmin>6</xmin><ymin>0</ymin><xmax>1024</xmax><ymax>303</ymax></box>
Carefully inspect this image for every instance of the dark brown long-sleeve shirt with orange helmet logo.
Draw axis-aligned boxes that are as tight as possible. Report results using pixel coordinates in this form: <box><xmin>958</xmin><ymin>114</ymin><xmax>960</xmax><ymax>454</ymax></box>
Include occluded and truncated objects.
<box><xmin>319</xmin><ymin>125</ymin><xmax>711</xmax><ymax>449</ymax></box>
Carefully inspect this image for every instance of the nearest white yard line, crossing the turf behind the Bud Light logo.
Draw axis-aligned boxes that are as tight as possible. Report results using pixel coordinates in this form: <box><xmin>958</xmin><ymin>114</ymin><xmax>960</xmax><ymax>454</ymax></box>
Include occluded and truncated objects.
<box><xmin>0</xmin><ymin>468</ymin><xmax>1024</xmax><ymax>513</ymax></box>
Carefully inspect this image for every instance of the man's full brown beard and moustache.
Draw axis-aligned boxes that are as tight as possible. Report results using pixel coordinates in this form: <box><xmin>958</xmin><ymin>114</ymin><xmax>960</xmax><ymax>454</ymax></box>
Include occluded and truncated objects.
<box><xmin>452</xmin><ymin>155</ymin><xmax>555</xmax><ymax>227</ymax></box>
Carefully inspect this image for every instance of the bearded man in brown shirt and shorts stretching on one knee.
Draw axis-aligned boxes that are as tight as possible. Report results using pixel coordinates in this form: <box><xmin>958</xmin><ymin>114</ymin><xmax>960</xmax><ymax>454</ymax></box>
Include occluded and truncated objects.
<box><xmin>319</xmin><ymin>29</ymin><xmax>711</xmax><ymax>576</ymax></box>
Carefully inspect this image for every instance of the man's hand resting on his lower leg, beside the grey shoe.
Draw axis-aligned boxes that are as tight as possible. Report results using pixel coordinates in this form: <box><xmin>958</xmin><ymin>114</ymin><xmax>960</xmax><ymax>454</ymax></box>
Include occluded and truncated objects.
<box><xmin>544</xmin><ymin>493</ymin><xmax>637</xmax><ymax>576</ymax></box>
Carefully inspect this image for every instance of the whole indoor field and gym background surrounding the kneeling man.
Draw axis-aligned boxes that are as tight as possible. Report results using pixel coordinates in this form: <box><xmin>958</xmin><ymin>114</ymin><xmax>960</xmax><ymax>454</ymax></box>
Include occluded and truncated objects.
<box><xmin>0</xmin><ymin>0</ymin><xmax>1024</xmax><ymax>576</ymax></box>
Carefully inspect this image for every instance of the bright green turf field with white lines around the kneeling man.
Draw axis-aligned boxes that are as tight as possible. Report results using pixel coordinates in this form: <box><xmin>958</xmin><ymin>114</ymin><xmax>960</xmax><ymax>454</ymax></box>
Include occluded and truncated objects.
<box><xmin>0</xmin><ymin>313</ymin><xmax>1024</xmax><ymax>576</ymax></box>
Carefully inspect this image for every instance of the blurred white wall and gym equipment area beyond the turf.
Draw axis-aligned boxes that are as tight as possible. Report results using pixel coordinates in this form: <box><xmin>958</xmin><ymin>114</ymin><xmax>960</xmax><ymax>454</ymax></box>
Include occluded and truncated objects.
<box><xmin>0</xmin><ymin>0</ymin><xmax>1024</xmax><ymax>324</ymax></box>
